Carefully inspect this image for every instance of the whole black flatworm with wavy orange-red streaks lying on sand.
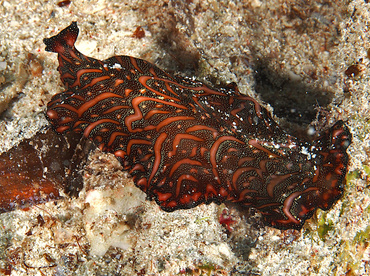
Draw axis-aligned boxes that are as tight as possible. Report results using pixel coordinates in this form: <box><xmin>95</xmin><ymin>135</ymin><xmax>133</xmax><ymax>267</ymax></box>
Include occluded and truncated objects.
<box><xmin>44</xmin><ymin>22</ymin><xmax>351</xmax><ymax>229</ymax></box>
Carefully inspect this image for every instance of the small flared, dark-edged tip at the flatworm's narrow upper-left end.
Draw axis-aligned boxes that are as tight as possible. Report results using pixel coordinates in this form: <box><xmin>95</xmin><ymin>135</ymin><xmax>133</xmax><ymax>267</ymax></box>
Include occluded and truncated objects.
<box><xmin>43</xmin><ymin>21</ymin><xmax>79</xmax><ymax>54</ymax></box>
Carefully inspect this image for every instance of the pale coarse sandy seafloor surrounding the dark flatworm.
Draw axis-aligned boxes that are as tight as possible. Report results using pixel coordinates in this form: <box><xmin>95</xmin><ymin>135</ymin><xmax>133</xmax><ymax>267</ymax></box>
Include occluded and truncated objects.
<box><xmin>0</xmin><ymin>0</ymin><xmax>370</xmax><ymax>276</ymax></box>
